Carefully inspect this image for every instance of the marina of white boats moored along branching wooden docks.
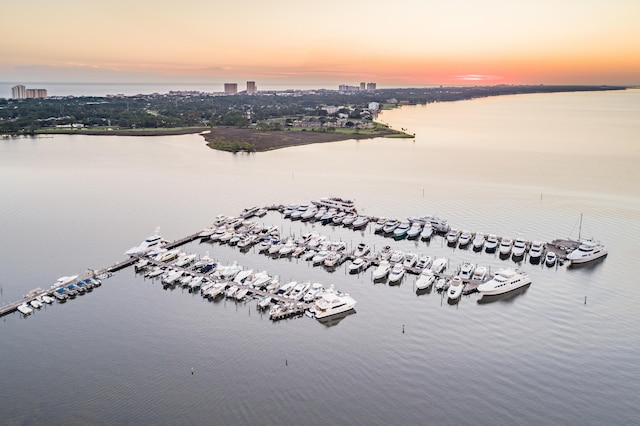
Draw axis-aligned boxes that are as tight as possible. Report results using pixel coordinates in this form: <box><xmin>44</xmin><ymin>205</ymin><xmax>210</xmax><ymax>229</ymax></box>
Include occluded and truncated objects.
<box><xmin>0</xmin><ymin>197</ymin><xmax>606</xmax><ymax>321</ymax></box>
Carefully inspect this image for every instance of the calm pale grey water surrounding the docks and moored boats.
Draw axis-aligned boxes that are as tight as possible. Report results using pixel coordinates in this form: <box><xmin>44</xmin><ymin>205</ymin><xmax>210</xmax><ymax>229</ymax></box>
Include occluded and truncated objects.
<box><xmin>0</xmin><ymin>91</ymin><xmax>640</xmax><ymax>425</ymax></box>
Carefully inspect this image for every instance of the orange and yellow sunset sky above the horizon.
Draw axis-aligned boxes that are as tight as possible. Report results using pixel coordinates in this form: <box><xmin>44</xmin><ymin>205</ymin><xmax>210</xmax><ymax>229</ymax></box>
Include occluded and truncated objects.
<box><xmin>0</xmin><ymin>0</ymin><xmax>640</xmax><ymax>87</ymax></box>
